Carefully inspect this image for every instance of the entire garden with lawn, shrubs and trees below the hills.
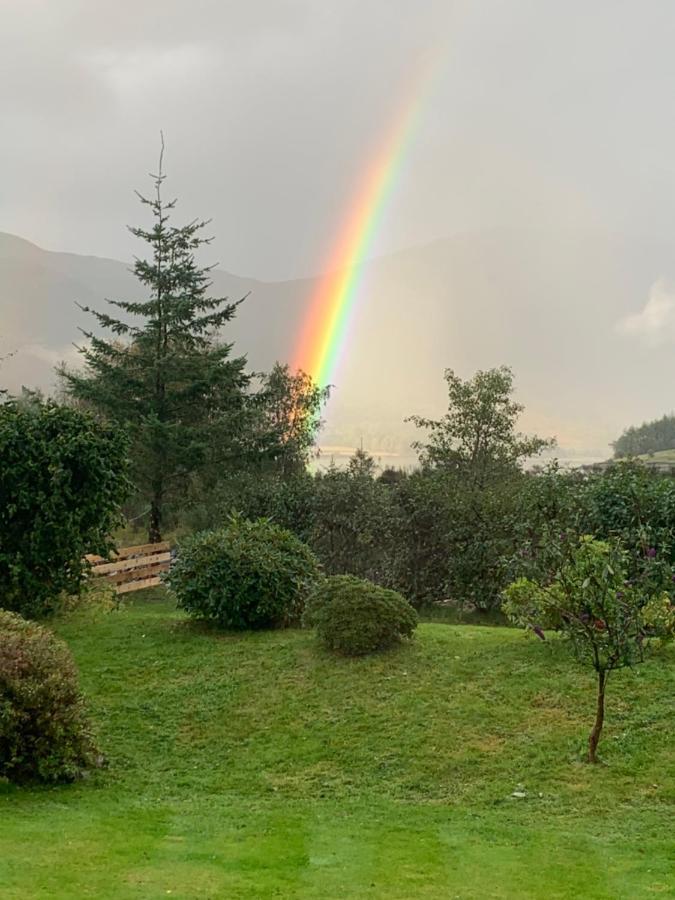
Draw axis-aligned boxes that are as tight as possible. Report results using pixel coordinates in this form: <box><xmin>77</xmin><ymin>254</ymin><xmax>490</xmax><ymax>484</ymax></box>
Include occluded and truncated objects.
<box><xmin>0</xmin><ymin>178</ymin><xmax>675</xmax><ymax>900</ymax></box>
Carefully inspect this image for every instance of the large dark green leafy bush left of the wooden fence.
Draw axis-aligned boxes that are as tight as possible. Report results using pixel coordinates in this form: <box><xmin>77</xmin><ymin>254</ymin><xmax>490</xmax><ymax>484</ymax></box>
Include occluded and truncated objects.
<box><xmin>0</xmin><ymin>397</ymin><xmax>129</xmax><ymax>618</ymax></box>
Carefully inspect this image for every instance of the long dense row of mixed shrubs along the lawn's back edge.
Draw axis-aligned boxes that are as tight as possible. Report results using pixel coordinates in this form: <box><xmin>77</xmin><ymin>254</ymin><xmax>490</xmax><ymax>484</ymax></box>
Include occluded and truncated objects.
<box><xmin>185</xmin><ymin>453</ymin><xmax>675</xmax><ymax>610</ymax></box>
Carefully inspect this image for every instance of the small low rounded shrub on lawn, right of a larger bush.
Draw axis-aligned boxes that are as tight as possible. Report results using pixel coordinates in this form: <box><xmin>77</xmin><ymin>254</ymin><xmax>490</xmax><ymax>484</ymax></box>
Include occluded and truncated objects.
<box><xmin>305</xmin><ymin>575</ymin><xmax>417</xmax><ymax>656</ymax></box>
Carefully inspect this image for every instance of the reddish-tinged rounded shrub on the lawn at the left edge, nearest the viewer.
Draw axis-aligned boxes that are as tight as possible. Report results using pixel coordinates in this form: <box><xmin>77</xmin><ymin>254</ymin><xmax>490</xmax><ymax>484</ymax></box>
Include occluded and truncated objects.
<box><xmin>0</xmin><ymin>610</ymin><xmax>96</xmax><ymax>782</ymax></box>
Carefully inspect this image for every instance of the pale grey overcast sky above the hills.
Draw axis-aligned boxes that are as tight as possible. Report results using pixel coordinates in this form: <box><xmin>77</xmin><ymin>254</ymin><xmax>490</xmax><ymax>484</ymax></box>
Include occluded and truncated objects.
<box><xmin>0</xmin><ymin>0</ymin><xmax>675</xmax><ymax>279</ymax></box>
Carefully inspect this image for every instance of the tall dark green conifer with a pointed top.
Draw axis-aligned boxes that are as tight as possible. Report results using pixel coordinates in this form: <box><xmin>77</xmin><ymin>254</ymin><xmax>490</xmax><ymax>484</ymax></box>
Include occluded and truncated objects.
<box><xmin>61</xmin><ymin>142</ymin><xmax>249</xmax><ymax>542</ymax></box>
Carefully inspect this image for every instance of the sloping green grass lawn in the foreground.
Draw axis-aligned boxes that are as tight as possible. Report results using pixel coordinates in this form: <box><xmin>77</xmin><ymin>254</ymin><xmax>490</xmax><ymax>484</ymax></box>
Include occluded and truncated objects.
<box><xmin>0</xmin><ymin>591</ymin><xmax>675</xmax><ymax>900</ymax></box>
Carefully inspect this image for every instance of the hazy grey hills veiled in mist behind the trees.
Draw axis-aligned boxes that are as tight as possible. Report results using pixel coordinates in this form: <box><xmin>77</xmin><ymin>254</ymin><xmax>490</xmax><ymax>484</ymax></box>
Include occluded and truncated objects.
<box><xmin>0</xmin><ymin>229</ymin><xmax>675</xmax><ymax>460</ymax></box>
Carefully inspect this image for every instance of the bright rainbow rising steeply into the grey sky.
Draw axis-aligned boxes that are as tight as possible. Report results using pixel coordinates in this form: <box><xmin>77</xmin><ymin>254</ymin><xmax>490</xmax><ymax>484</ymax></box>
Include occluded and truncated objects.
<box><xmin>293</xmin><ymin>63</ymin><xmax>436</xmax><ymax>386</ymax></box>
